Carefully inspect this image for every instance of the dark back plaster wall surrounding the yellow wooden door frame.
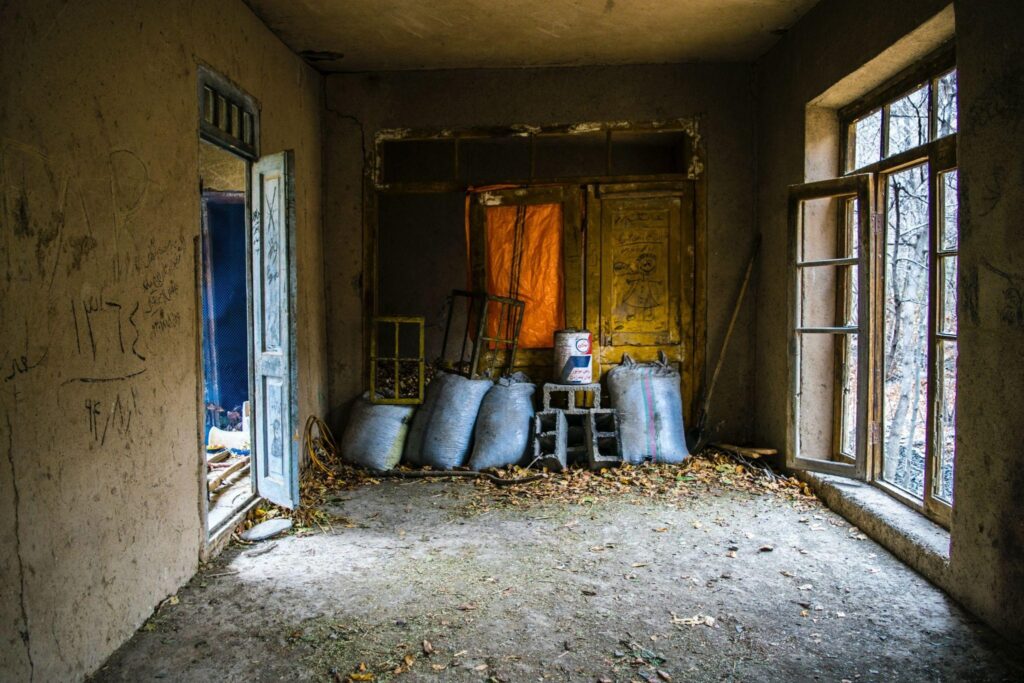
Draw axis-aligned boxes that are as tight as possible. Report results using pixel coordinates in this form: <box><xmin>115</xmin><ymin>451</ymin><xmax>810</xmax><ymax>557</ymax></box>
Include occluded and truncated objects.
<box><xmin>325</xmin><ymin>65</ymin><xmax>755</xmax><ymax>441</ymax></box>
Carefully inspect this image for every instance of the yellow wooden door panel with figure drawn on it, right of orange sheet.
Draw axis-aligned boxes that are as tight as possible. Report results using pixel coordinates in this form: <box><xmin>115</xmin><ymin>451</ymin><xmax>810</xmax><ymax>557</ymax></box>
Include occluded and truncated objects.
<box><xmin>586</xmin><ymin>182</ymin><xmax>697</xmax><ymax>428</ymax></box>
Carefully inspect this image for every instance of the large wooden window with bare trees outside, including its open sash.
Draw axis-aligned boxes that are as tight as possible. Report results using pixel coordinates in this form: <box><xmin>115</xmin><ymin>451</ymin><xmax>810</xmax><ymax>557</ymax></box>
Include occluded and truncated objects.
<box><xmin>791</xmin><ymin>48</ymin><xmax>958</xmax><ymax>525</ymax></box>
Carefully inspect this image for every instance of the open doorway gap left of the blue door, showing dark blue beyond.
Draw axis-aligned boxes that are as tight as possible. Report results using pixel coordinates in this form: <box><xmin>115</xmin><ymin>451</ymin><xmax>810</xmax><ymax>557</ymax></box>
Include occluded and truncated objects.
<box><xmin>199</xmin><ymin>140</ymin><xmax>255</xmax><ymax>536</ymax></box>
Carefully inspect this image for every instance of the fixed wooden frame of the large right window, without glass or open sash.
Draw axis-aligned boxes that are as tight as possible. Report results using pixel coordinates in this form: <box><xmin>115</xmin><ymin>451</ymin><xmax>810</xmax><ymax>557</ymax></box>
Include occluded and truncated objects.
<box><xmin>834</xmin><ymin>48</ymin><xmax>959</xmax><ymax>528</ymax></box>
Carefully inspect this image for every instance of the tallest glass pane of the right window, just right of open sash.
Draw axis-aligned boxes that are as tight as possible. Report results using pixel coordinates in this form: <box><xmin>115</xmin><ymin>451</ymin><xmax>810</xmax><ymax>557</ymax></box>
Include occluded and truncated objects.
<box><xmin>883</xmin><ymin>165</ymin><xmax>929</xmax><ymax>497</ymax></box>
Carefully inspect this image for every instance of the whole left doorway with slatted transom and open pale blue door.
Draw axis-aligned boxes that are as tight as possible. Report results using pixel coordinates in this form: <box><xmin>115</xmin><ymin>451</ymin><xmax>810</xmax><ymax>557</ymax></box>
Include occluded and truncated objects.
<box><xmin>197</xmin><ymin>67</ymin><xmax>300</xmax><ymax>553</ymax></box>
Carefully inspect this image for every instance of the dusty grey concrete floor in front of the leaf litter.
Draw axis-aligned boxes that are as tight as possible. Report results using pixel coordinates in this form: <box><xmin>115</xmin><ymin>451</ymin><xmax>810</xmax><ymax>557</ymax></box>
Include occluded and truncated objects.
<box><xmin>95</xmin><ymin>480</ymin><xmax>1024</xmax><ymax>683</ymax></box>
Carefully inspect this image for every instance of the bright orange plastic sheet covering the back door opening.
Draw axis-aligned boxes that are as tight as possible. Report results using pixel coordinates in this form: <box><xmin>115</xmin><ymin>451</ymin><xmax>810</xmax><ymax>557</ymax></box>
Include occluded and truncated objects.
<box><xmin>484</xmin><ymin>204</ymin><xmax>565</xmax><ymax>348</ymax></box>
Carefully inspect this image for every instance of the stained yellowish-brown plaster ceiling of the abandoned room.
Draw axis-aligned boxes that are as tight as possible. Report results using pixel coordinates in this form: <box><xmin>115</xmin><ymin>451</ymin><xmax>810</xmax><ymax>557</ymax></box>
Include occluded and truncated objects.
<box><xmin>246</xmin><ymin>0</ymin><xmax>817</xmax><ymax>72</ymax></box>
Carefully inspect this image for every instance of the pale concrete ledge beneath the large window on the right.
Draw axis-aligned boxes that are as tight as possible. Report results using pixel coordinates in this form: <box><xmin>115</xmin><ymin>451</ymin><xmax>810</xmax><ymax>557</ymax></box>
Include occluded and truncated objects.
<box><xmin>797</xmin><ymin>472</ymin><xmax>949</xmax><ymax>588</ymax></box>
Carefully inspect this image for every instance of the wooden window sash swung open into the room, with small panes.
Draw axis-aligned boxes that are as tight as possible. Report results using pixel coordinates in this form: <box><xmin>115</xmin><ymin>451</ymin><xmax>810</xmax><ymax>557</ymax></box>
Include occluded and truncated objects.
<box><xmin>786</xmin><ymin>174</ymin><xmax>879</xmax><ymax>479</ymax></box>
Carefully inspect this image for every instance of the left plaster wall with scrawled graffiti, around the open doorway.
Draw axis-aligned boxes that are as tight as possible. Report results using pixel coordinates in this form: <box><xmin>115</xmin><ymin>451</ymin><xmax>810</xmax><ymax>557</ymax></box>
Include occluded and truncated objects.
<box><xmin>0</xmin><ymin>0</ymin><xmax>325</xmax><ymax>681</ymax></box>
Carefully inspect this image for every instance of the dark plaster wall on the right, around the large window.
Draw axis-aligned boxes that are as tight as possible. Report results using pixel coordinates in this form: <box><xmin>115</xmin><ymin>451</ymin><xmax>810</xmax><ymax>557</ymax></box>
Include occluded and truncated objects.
<box><xmin>756</xmin><ymin>0</ymin><xmax>1024</xmax><ymax>640</ymax></box>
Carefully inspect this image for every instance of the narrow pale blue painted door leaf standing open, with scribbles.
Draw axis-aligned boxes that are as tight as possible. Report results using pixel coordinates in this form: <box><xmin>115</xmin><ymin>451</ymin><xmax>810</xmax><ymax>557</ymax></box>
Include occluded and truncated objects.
<box><xmin>251</xmin><ymin>152</ymin><xmax>299</xmax><ymax>508</ymax></box>
